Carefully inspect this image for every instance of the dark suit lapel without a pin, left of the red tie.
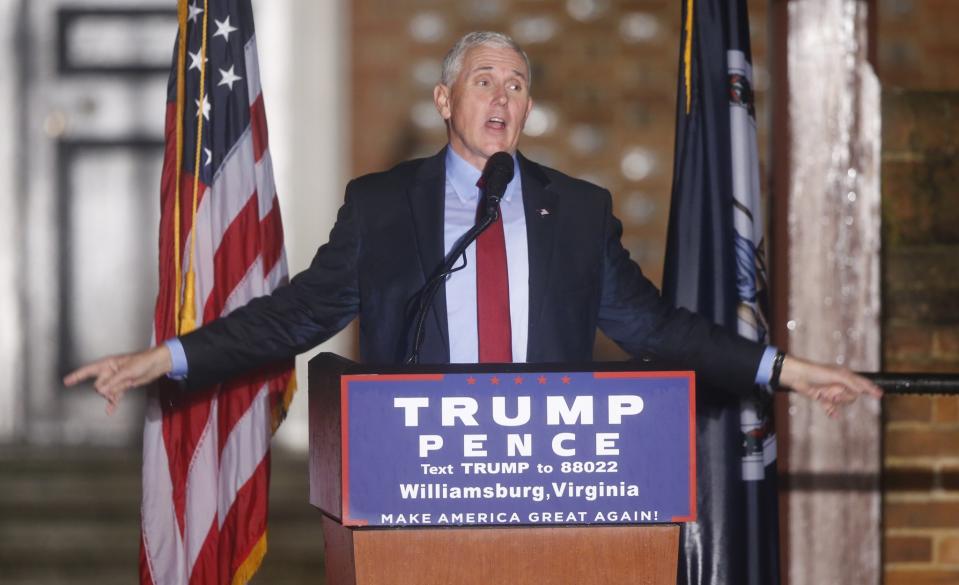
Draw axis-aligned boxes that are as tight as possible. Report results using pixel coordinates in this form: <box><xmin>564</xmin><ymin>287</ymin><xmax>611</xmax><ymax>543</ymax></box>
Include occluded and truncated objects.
<box><xmin>407</xmin><ymin>149</ymin><xmax>449</xmax><ymax>361</ymax></box>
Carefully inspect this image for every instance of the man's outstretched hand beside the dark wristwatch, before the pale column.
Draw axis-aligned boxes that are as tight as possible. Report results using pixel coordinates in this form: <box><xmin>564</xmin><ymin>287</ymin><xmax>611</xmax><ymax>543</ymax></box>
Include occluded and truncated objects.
<box><xmin>779</xmin><ymin>356</ymin><xmax>882</xmax><ymax>417</ymax></box>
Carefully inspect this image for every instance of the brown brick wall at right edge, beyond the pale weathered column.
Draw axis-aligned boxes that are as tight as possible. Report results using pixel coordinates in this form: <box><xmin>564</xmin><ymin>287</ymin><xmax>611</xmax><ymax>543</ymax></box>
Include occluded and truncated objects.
<box><xmin>882</xmin><ymin>90</ymin><xmax>959</xmax><ymax>585</ymax></box>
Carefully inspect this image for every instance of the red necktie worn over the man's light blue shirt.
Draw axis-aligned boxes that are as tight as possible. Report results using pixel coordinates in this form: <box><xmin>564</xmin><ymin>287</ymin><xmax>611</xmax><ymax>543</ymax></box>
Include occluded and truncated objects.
<box><xmin>476</xmin><ymin>196</ymin><xmax>513</xmax><ymax>363</ymax></box>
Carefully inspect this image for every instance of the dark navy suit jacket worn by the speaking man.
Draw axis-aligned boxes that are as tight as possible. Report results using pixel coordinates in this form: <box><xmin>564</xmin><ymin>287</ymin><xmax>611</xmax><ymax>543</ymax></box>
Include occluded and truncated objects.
<box><xmin>181</xmin><ymin>151</ymin><xmax>763</xmax><ymax>388</ymax></box>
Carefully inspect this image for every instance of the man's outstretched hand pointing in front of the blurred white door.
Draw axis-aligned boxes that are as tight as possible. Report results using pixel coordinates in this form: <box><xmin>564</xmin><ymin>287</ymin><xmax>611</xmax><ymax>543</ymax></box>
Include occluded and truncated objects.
<box><xmin>63</xmin><ymin>345</ymin><xmax>173</xmax><ymax>414</ymax></box>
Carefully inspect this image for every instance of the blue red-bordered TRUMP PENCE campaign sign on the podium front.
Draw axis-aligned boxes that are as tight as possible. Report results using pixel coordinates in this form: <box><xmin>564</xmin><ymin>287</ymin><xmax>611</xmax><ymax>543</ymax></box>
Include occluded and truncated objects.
<box><xmin>341</xmin><ymin>372</ymin><xmax>696</xmax><ymax>526</ymax></box>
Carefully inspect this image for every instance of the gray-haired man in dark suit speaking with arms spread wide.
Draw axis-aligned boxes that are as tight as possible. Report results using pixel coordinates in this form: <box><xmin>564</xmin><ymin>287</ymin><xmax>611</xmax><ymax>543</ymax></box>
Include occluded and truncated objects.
<box><xmin>65</xmin><ymin>33</ymin><xmax>880</xmax><ymax>412</ymax></box>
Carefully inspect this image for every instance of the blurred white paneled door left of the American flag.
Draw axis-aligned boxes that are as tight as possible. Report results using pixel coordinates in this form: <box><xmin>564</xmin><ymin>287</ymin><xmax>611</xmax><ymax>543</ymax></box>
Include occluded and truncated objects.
<box><xmin>11</xmin><ymin>0</ymin><xmax>176</xmax><ymax>444</ymax></box>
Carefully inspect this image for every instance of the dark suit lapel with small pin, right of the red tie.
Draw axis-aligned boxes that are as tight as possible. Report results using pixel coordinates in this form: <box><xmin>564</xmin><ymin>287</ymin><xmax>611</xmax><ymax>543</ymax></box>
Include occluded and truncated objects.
<box><xmin>519</xmin><ymin>155</ymin><xmax>559</xmax><ymax>360</ymax></box>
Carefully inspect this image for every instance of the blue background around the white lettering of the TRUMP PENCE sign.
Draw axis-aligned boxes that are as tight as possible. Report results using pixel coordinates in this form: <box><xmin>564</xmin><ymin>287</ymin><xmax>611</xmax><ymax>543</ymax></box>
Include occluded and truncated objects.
<box><xmin>343</xmin><ymin>372</ymin><xmax>695</xmax><ymax>525</ymax></box>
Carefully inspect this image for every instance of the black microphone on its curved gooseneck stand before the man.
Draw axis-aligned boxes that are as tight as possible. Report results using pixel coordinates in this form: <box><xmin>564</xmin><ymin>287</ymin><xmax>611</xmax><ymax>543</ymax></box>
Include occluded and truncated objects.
<box><xmin>406</xmin><ymin>152</ymin><xmax>515</xmax><ymax>364</ymax></box>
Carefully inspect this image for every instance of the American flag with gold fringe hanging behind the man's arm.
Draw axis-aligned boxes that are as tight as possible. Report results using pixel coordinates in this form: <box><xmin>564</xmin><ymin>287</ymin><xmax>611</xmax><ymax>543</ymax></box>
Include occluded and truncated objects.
<box><xmin>140</xmin><ymin>0</ymin><xmax>294</xmax><ymax>585</ymax></box>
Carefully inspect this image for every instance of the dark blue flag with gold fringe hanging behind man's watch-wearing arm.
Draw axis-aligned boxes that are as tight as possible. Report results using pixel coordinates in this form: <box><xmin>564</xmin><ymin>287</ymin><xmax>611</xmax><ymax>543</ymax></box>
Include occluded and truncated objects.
<box><xmin>663</xmin><ymin>0</ymin><xmax>779</xmax><ymax>585</ymax></box>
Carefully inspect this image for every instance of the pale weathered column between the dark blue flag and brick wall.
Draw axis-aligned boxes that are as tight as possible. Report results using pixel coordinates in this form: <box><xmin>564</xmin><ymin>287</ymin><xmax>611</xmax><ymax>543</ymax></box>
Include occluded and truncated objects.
<box><xmin>787</xmin><ymin>0</ymin><xmax>880</xmax><ymax>585</ymax></box>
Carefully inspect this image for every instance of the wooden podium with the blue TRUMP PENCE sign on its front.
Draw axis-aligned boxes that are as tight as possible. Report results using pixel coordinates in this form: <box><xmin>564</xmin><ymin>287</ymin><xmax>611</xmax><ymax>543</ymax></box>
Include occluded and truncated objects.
<box><xmin>309</xmin><ymin>353</ymin><xmax>696</xmax><ymax>585</ymax></box>
